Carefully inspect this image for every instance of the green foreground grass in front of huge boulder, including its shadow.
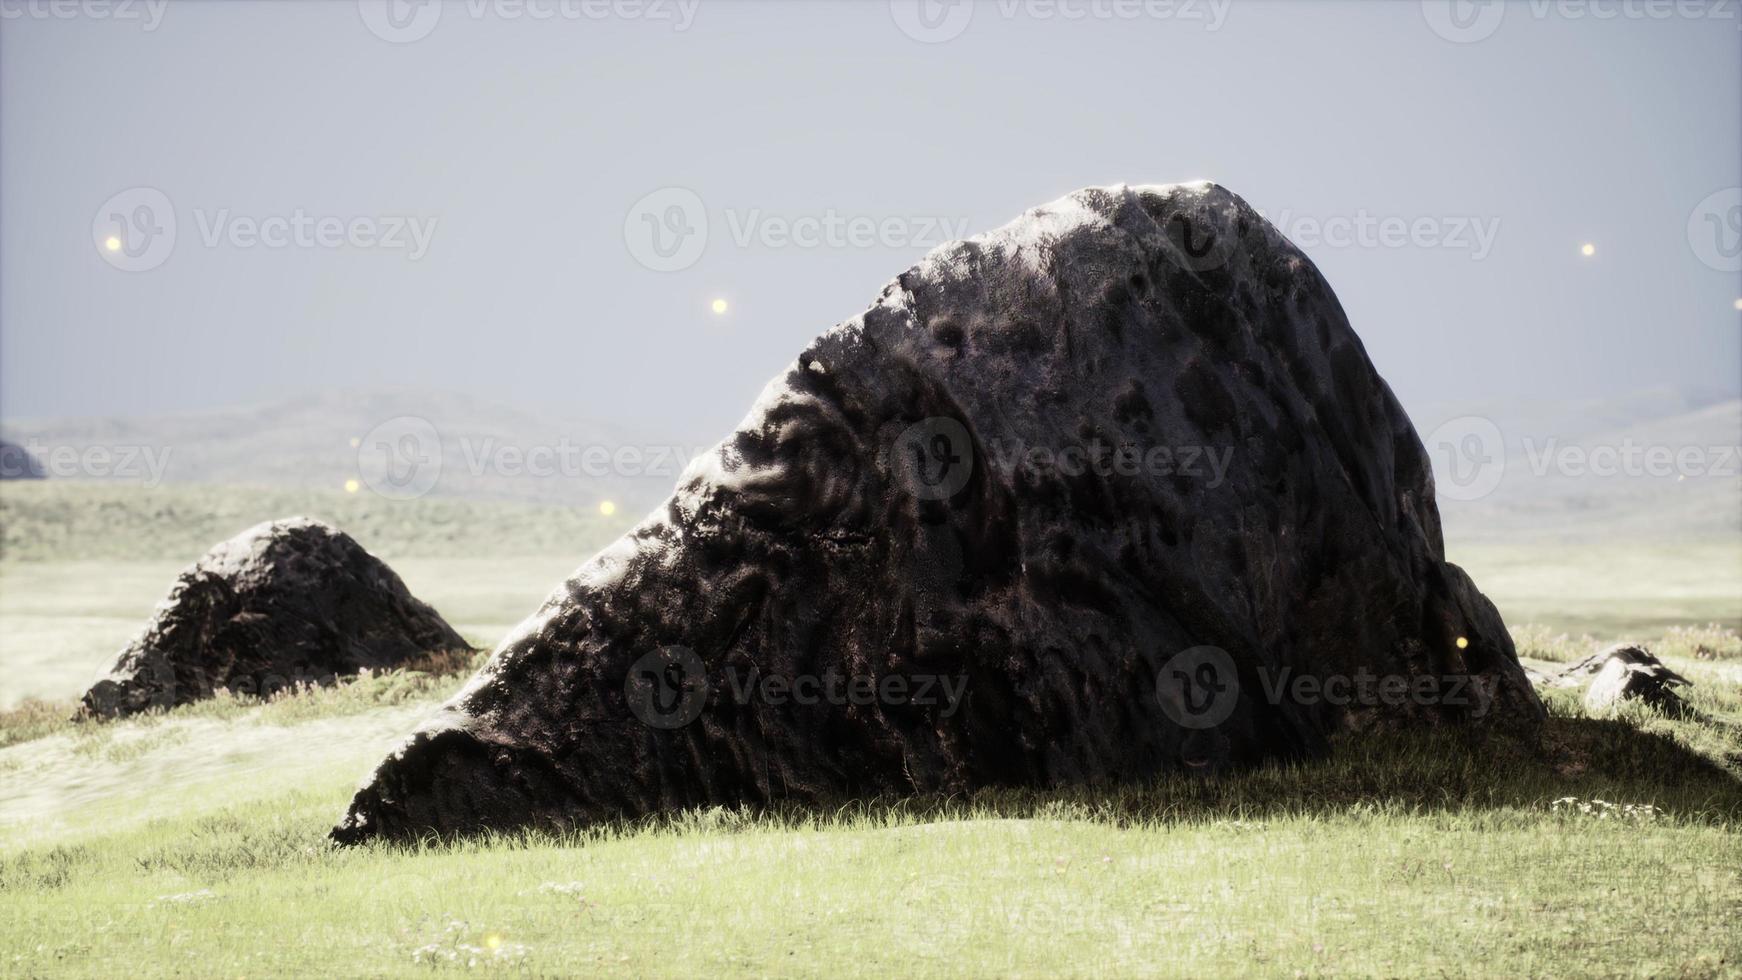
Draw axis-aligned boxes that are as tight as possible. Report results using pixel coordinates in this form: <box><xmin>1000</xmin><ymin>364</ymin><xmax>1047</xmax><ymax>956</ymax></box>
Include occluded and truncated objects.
<box><xmin>0</xmin><ymin>717</ymin><xmax>1742</xmax><ymax>977</ymax></box>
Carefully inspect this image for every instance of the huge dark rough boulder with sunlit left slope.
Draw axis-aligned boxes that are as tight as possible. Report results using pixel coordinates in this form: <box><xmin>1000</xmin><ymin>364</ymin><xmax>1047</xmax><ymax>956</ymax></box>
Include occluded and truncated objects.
<box><xmin>333</xmin><ymin>183</ymin><xmax>1542</xmax><ymax>842</ymax></box>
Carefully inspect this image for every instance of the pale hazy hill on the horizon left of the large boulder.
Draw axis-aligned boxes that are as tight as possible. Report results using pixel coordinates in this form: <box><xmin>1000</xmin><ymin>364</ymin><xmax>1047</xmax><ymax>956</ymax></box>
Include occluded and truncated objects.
<box><xmin>0</xmin><ymin>390</ymin><xmax>706</xmax><ymax>510</ymax></box>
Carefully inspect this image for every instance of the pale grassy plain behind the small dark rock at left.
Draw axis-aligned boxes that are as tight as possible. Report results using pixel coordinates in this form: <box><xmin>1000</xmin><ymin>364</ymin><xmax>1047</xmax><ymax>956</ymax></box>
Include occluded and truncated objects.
<box><xmin>0</xmin><ymin>480</ymin><xmax>627</xmax><ymax>708</ymax></box>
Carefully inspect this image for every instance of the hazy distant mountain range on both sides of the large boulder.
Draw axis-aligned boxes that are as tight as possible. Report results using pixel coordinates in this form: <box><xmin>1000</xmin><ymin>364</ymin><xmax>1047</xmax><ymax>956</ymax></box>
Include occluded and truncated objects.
<box><xmin>0</xmin><ymin>388</ymin><xmax>1742</xmax><ymax>541</ymax></box>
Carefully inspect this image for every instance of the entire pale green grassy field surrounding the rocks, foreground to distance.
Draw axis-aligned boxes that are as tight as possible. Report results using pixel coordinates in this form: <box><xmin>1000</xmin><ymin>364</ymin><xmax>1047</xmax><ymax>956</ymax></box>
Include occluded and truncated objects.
<box><xmin>0</xmin><ymin>486</ymin><xmax>1742</xmax><ymax>977</ymax></box>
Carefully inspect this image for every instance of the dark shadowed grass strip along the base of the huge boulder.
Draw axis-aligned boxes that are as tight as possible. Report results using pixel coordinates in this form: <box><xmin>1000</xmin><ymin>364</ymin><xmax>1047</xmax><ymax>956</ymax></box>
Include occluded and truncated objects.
<box><xmin>384</xmin><ymin>717</ymin><xmax>1742</xmax><ymax>851</ymax></box>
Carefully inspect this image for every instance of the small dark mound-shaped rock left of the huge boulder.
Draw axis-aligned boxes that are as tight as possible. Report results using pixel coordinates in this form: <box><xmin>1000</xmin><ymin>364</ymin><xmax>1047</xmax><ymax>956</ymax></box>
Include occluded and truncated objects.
<box><xmin>84</xmin><ymin>517</ymin><xmax>467</xmax><ymax>715</ymax></box>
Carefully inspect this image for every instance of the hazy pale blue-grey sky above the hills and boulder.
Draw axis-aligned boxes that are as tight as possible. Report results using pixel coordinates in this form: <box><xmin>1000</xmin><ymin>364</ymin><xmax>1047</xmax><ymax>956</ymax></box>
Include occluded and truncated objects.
<box><xmin>0</xmin><ymin>0</ymin><xmax>1742</xmax><ymax>439</ymax></box>
